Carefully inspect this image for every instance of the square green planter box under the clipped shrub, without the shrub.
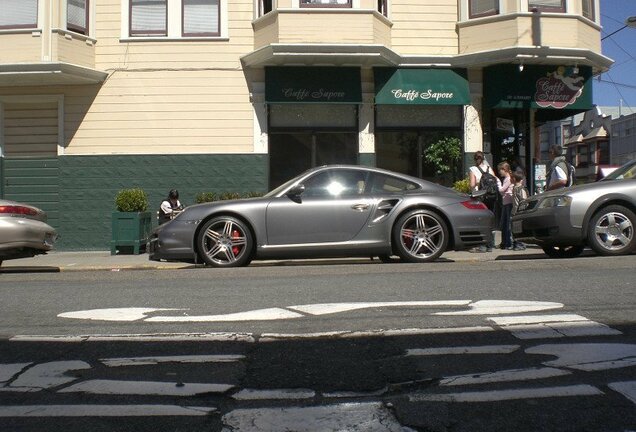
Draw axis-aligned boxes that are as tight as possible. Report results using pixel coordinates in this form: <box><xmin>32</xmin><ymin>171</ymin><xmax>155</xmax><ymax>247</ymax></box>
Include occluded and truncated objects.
<box><xmin>110</xmin><ymin>212</ymin><xmax>152</xmax><ymax>255</ymax></box>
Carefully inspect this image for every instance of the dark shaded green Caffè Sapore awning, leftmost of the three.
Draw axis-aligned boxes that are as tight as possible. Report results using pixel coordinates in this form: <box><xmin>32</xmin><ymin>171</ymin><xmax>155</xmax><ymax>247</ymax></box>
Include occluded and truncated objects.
<box><xmin>265</xmin><ymin>66</ymin><xmax>362</xmax><ymax>104</ymax></box>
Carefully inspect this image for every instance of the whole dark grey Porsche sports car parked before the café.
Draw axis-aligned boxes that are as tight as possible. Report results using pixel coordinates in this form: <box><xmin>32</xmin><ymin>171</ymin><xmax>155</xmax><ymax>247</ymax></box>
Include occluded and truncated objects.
<box><xmin>148</xmin><ymin>165</ymin><xmax>494</xmax><ymax>267</ymax></box>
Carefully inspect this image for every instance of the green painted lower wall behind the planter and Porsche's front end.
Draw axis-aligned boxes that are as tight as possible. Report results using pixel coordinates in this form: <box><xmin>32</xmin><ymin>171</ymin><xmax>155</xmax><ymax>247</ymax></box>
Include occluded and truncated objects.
<box><xmin>56</xmin><ymin>154</ymin><xmax>268</xmax><ymax>250</ymax></box>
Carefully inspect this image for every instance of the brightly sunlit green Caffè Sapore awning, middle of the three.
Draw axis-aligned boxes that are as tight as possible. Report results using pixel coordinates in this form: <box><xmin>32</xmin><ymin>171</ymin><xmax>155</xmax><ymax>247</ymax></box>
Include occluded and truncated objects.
<box><xmin>373</xmin><ymin>68</ymin><xmax>470</xmax><ymax>105</ymax></box>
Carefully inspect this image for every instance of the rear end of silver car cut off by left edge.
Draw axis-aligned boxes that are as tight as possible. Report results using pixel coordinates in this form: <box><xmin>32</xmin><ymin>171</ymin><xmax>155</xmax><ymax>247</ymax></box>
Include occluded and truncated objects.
<box><xmin>0</xmin><ymin>200</ymin><xmax>57</xmax><ymax>264</ymax></box>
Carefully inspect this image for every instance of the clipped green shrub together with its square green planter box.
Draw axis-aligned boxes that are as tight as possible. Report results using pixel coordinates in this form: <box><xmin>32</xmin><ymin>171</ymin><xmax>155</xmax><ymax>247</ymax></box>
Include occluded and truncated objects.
<box><xmin>110</xmin><ymin>188</ymin><xmax>152</xmax><ymax>255</ymax></box>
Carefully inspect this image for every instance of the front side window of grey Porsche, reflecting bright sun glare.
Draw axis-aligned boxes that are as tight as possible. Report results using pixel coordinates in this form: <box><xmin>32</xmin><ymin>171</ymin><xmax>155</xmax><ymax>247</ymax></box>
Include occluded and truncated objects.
<box><xmin>303</xmin><ymin>170</ymin><xmax>367</xmax><ymax>198</ymax></box>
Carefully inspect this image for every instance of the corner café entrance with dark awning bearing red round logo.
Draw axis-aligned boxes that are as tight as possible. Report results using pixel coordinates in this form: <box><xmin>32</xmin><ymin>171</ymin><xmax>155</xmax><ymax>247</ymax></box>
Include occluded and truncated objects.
<box><xmin>483</xmin><ymin>64</ymin><xmax>592</xmax><ymax>192</ymax></box>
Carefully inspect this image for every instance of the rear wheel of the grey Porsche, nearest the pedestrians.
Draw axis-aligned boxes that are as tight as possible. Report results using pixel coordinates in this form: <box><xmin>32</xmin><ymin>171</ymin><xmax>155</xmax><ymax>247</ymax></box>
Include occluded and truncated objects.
<box><xmin>393</xmin><ymin>209</ymin><xmax>448</xmax><ymax>263</ymax></box>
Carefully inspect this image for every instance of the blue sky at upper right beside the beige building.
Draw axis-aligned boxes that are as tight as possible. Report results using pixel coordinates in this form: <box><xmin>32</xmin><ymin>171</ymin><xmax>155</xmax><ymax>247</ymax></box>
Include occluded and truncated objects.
<box><xmin>593</xmin><ymin>0</ymin><xmax>636</xmax><ymax>115</ymax></box>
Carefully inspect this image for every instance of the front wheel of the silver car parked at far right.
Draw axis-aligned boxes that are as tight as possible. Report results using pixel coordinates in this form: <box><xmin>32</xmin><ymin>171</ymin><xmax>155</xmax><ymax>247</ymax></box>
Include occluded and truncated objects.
<box><xmin>587</xmin><ymin>205</ymin><xmax>636</xmax><ymax>256</ymax></box>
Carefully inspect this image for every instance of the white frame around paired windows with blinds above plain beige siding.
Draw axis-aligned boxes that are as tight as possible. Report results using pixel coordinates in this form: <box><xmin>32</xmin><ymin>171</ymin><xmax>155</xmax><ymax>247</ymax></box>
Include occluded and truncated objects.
<box><xmin>120</xmin><ymin>0</ymin><xmax>229</xmax><ymax>41</ymax></box>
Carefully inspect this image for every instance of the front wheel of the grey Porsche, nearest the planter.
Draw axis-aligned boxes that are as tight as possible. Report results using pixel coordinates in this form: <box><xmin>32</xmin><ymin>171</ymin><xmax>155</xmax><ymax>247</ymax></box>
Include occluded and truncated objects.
<box><xmin>197</xmin><ymin>216</ymin><xmax>254</xmax><ymax>267</ymax></box>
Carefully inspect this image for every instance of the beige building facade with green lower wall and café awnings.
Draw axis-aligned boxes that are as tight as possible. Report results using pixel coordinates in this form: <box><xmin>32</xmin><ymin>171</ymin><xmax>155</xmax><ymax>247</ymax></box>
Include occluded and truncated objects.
<box><xmin>0</xmin><ymin>0</ymin><xmax>611</xmax><ymax>249</ymax></box>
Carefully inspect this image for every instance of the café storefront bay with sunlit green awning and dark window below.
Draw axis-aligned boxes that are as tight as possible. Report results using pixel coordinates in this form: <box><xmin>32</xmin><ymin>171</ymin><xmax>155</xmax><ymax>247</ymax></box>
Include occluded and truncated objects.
<box><xmin>374</xmin><ymin>68</ymin><xmax>470</xmax><ymax>186</ymax></box>
